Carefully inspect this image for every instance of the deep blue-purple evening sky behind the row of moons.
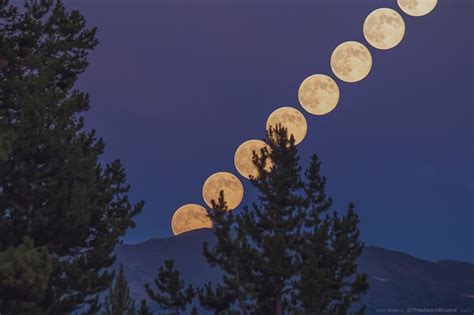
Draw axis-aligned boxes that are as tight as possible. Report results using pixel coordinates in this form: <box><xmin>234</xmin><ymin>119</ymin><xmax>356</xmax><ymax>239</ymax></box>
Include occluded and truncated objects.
<box><xmin>65</xmin><ymin>0</ymin><xmax>474</xmax><ymax>262</ymax></box>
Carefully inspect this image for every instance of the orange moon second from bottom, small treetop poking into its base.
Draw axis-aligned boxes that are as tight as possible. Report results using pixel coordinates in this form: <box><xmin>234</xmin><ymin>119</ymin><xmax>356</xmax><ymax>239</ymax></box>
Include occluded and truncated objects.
<box><xmin>202</xmin><ymin>172</ymin><xmax>244</xmax><ymax>210</ymax></box>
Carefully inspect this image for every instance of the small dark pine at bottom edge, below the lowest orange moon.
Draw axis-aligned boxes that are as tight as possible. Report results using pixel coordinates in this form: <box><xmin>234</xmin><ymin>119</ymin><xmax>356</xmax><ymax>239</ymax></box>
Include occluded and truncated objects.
<box><xmin>145</xmin><ymin>260</ymin><xmax>196</xmax><ymax>314</ymax></box>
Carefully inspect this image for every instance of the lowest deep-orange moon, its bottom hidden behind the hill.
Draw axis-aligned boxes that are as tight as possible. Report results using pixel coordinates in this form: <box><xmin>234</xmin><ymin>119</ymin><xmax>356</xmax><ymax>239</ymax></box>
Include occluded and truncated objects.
<box><xmin>171</xmin><ymin>204</ymin><xmax>212</xmax><ymax>235</ymax></box>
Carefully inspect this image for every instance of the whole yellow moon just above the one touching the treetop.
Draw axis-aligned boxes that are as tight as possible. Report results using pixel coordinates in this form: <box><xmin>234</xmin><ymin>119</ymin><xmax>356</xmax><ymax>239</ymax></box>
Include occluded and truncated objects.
<box><xmin>298</xmin><ymin>74</ymin><xmax>339</xmax><ymax>115</ymax></box>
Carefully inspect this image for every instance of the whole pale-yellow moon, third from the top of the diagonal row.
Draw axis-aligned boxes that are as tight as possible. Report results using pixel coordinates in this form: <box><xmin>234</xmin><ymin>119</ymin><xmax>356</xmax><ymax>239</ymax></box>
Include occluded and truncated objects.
<box><xmin>331</xmin><ymin>41</ymin><xmax>372</xmax><ymax>83</ymax></box>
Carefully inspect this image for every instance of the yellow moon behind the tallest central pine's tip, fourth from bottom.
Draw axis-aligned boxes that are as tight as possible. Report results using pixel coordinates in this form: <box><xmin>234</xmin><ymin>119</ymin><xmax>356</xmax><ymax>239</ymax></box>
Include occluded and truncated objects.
<box><xmin>267</xmin><ymin>107</ymin><xmax>308</xmax><ymax>144</ymax></box>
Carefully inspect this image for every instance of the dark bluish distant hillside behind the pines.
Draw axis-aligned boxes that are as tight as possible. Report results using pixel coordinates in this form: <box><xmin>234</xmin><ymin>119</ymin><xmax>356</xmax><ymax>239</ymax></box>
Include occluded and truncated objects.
<box><xmin>116</xmin><ymin>229</ymin><xmax>474</xmax><ymax>314</ymax></box>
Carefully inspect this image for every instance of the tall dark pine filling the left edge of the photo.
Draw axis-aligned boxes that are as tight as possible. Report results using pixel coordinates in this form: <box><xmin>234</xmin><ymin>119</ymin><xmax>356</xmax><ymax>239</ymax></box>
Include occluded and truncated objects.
<box><xmin>0</xmin><ymin>0</ymin><xmax>142</xmax><ymax>314</ymax></box>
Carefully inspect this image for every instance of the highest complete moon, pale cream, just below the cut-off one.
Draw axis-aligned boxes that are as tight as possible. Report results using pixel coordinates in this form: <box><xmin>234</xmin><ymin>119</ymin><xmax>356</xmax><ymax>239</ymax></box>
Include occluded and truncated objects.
<box><xmin>364</xmin><ymin>8</ymin><xmax>405</xmax><ymax>49</ymax></box>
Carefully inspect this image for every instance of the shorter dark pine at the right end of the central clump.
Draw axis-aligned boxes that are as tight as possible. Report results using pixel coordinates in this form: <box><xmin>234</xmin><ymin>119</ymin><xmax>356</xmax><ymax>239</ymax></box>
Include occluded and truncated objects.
<box><xmin>292</xmin><ymin>155</ymin><xmax>368</xmax><ymax>314</ymax></box>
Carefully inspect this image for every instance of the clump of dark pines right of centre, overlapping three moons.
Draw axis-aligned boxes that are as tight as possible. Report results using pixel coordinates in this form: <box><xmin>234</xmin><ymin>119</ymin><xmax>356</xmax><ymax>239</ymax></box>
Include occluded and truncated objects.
<box><xmin>200</xmin><ymin>126</ymin><xmax>367</xmax><ymax>315</ymax></box>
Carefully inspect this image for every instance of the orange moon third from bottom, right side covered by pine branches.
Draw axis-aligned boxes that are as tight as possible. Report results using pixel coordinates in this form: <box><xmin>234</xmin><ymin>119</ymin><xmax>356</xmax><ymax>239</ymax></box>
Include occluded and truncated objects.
<box><xmin>234</xmin><ymin>140</ymin><xmax>272</xmax><ymax>178</ymax></box>
